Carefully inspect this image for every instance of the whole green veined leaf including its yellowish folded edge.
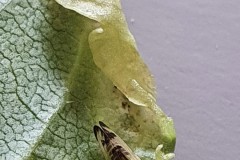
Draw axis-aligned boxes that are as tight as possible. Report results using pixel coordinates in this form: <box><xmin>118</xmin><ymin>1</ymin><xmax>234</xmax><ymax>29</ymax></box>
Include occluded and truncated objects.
<box><xmin>0</xmin><ymin>0</ymin><xmax>175</xmax><ymax>160</ymax></box>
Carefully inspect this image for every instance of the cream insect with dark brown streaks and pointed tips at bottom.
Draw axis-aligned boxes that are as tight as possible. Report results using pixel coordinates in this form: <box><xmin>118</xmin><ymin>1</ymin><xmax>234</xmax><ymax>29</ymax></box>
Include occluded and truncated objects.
<box><xmin>93</xmin><ymin>121</ymin><xmax>140</xmax><ymax>160</ymax></box>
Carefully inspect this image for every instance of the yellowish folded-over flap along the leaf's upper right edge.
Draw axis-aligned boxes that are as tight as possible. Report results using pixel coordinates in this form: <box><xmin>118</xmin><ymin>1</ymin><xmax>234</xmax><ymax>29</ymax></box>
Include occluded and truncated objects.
<box><xmin>56</xmin><ymin>0</ymin><xmax>156</xmax><ymax>106</ymax></box>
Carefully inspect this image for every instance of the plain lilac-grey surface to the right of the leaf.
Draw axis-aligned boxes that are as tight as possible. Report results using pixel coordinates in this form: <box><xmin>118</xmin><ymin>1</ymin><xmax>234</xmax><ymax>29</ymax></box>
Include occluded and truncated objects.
<box><xmin>122</xmin><ymin>0</ymin><xmax>240</xmax><ymax>160</ymax></box>
